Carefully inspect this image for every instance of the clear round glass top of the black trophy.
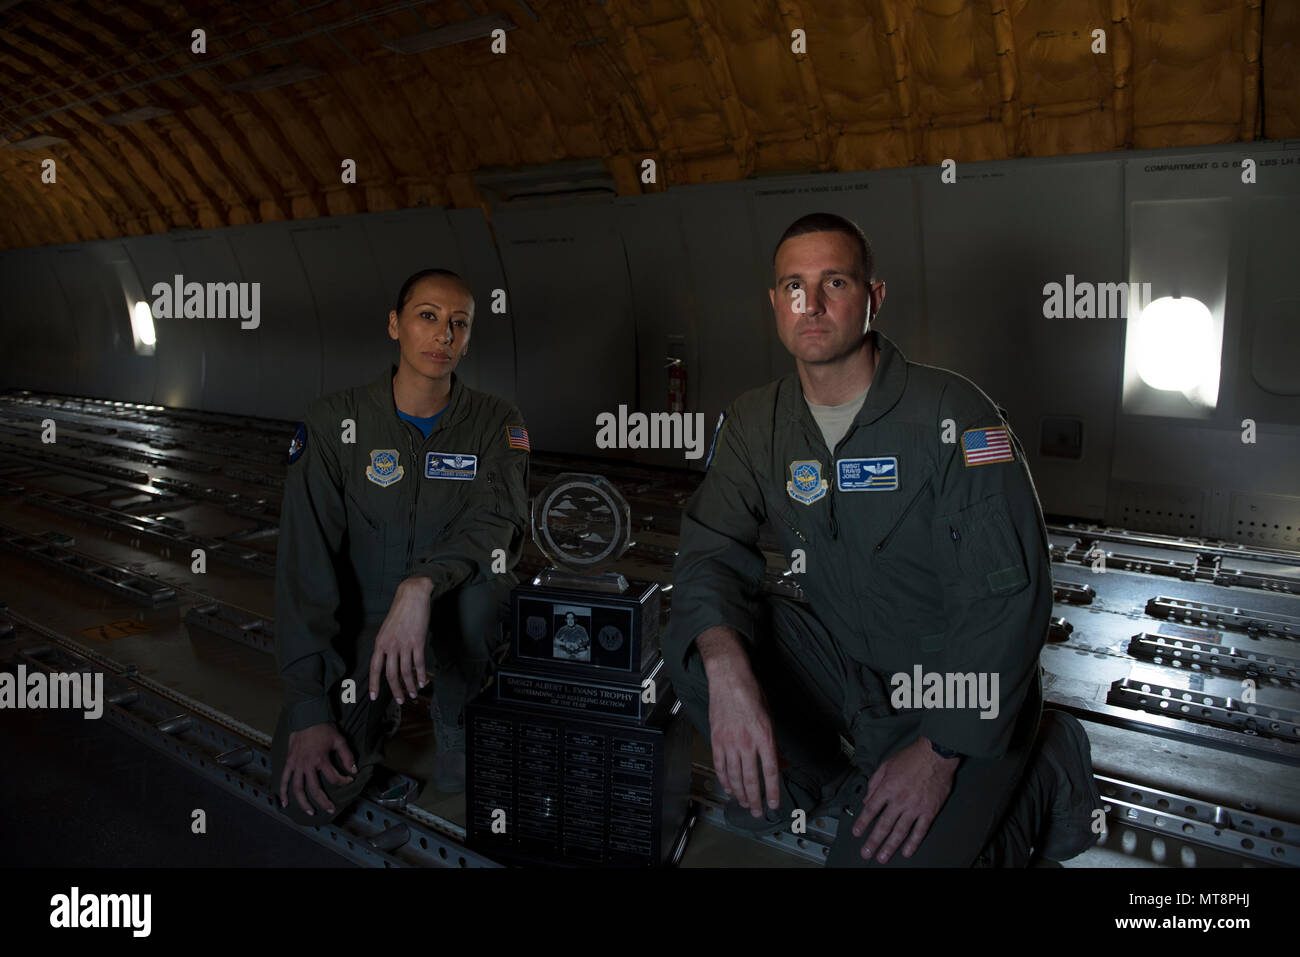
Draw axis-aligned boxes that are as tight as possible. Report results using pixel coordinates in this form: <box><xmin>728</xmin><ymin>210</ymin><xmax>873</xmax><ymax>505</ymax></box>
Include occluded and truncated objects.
<box><xmin>532</xmin><ymin>472</ymin><xmax>632</xmax><ymax>594</ymax></box>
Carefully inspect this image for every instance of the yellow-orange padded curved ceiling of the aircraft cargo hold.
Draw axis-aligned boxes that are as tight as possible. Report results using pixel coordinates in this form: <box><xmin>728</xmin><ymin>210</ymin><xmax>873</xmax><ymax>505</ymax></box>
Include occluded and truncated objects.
<box><xmin>0</xmin><ymin>0</ymin><xmax>1300</xmax><ymax>248</ymax></box>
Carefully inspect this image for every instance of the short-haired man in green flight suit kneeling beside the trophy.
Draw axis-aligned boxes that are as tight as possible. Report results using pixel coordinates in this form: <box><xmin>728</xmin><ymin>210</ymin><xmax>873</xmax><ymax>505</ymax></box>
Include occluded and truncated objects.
<box><xmin>664</xmin><ymin>213</ymin><xmax>1100</xmax><ymax>867</ymax></box>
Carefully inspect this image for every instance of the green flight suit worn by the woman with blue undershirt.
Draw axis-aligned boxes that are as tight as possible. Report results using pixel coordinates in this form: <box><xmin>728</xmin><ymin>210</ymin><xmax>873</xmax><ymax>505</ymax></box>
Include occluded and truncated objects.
<box><xmin>272</xmin><ymin>367</ymin><xmax>529</xmax><ymax>824</ymax></box>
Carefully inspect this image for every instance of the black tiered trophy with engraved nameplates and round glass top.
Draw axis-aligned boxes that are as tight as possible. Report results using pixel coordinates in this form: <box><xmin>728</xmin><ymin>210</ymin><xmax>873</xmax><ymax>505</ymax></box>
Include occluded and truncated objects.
<box><xmin>467</xmin><ymin>472</ymin><xmax>690</xmax><ymax>866</ymax></box>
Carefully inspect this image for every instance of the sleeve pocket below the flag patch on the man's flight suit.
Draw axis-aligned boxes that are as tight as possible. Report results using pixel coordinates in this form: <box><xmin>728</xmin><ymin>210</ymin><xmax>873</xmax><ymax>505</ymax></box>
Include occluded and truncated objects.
<box><xmin>940</xmin><ymin>495</ymin><xmax>1030</xmax><ymax>598</ymax></box>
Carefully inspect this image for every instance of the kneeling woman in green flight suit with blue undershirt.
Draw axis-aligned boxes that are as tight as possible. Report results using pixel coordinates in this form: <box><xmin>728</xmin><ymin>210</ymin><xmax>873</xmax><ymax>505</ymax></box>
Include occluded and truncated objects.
<box><xmin>272</xmin><ymin>269</ymin><xmax>529</xmax><ymax>824</ymax></box>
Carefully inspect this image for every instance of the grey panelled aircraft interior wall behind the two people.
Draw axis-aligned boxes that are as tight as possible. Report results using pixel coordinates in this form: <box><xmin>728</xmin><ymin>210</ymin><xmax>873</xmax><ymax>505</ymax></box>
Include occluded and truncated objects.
<box><xmin>0</xmin><ymin>136</ymin><xmax>1300</xmax><ymax>538</ymax></box>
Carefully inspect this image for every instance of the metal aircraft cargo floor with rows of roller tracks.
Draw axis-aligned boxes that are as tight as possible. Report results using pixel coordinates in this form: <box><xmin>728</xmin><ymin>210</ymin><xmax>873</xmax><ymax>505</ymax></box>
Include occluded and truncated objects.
<box><xmin>0</xmin><ymin>393</ymin><xmax>1300</xmax><ymax>867</ymax></box>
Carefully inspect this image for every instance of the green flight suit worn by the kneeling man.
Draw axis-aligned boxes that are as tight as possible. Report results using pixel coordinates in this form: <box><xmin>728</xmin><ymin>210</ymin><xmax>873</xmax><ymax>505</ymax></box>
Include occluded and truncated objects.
<box><xmin>664</xmin><ymin>332</ymin><xmax>1052</xmax><ymax>866</ymax></box>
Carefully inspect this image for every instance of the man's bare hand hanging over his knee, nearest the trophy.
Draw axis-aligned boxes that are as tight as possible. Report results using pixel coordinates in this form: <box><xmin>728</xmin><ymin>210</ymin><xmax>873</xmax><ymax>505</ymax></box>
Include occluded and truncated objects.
<box><xmin>696</xmin><ymin>625</ymin><xmax>780</xmax><ymax>818</ymax></box>
